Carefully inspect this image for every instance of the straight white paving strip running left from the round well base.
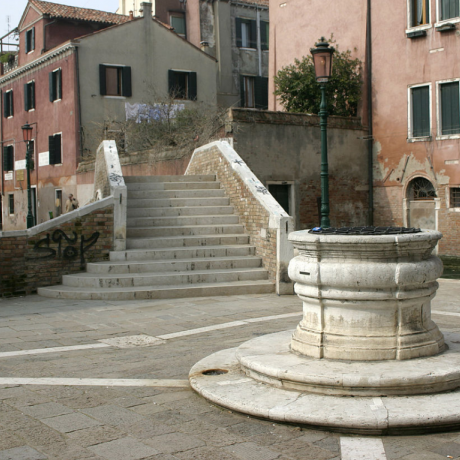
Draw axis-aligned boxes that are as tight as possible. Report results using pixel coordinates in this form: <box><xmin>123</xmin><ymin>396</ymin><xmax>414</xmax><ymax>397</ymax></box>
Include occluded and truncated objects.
<box><xmin>0</xmin><ymin>377</ymin><xmax>190</xmax><ymax>388</ymax></box>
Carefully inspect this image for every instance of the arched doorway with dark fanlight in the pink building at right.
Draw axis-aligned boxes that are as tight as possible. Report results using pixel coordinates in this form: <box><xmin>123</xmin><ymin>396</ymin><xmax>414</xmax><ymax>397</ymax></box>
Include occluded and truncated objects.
<box><xmin>406</xmin><ymin>177</ymin><xmax>439</xmax><ymax>230</ymax></box>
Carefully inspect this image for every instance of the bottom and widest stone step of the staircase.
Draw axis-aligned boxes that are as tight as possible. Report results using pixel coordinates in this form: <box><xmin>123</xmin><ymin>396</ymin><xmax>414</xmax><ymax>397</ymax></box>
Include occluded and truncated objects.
<box><xmin>38</xmin><ymin>280</ymin><xmax>275</xmax><ymax>300</ymax></box>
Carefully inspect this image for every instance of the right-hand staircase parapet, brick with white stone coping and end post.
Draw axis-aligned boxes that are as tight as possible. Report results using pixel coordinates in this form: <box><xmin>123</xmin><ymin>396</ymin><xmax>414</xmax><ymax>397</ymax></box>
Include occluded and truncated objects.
<box><xmin>185</xmin><ymin>142</ymin><xmax>294</xmax><ymax>294</ymax></box>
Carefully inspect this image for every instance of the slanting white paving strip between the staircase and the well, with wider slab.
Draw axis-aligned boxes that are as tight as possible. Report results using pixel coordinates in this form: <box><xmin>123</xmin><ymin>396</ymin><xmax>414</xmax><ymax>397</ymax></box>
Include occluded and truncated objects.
<box><xmin>0</xmin><ymin>312</ymin><xmax>302</xmax><ymax>358</ymax></box>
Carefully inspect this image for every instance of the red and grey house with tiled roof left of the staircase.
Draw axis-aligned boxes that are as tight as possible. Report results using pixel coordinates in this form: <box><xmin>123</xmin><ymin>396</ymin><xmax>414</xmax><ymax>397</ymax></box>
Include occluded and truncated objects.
<box><xmin>0</xmin><ymin>0</ymin><xmax>216</xmax><ymax>230</ymax></box>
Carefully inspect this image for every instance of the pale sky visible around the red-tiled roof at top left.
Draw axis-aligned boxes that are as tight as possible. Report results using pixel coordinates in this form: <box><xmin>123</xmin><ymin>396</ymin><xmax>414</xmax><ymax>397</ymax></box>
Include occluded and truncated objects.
<box><xmin>0</xmin><ymin>0</ymin><xmax>118</xmax><ymax>37</ymax></box>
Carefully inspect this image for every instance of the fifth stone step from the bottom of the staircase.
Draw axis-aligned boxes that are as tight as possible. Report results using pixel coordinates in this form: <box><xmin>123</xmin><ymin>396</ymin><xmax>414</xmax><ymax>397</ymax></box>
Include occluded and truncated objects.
<box><xmin>124</xmin><ymin>234</ymin><xmax>250</xmax><ymax>250</ymax></box>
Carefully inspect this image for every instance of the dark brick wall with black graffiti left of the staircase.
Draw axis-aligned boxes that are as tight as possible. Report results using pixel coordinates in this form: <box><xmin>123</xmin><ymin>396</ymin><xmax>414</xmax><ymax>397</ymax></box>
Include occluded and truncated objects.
<box><xmin>0</xmin><ymin>204</ymin><xmax>113</xmax><ymax>296</ymax></box>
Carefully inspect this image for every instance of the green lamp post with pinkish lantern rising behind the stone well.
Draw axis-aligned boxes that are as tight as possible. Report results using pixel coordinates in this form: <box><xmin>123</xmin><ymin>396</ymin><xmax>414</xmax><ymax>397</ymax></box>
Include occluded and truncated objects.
<box><xmin>310</xmin><ymin>37</ymin><xmax>335</xmax><ymax>228</ymax></box>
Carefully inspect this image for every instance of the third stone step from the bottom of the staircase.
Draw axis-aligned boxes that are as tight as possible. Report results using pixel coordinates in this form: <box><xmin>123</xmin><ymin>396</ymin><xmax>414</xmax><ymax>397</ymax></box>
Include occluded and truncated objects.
<box><xmin>86</xmin><ymin>255</ymin><xmax>262</xmax><ymax>275</ymax></box>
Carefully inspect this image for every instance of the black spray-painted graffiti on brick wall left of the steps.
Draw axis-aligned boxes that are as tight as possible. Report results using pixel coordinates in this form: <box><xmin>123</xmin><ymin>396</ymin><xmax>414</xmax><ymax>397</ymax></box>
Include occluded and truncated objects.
<box><xmin>29</xmin><ymin>229</ymin><xmax>100</xmax><ymax>267</ymax></box>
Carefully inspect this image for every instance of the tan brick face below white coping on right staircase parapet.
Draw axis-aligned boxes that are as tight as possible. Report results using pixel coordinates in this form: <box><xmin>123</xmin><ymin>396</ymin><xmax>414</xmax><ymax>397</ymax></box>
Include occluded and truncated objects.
<box><xmin>186</xmin><ymin>147</ymin><xmax>277</xmax><ymax>282</ymax></box>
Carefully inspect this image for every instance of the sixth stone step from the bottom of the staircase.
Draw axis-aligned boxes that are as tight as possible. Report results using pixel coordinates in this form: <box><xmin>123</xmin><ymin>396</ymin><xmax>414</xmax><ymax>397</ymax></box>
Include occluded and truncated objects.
<box><xmin>126</xmin><ymin>224</ymin><xmax>244</xmax><ymax>238</ymax></box>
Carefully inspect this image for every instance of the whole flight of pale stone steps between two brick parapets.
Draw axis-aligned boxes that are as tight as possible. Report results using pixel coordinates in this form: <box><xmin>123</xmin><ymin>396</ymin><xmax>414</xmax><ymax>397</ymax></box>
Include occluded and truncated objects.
<box><xmin>38</xmin><ymin>175</ymin><xmax>275</xmax><ymax>300</ymax></box>
